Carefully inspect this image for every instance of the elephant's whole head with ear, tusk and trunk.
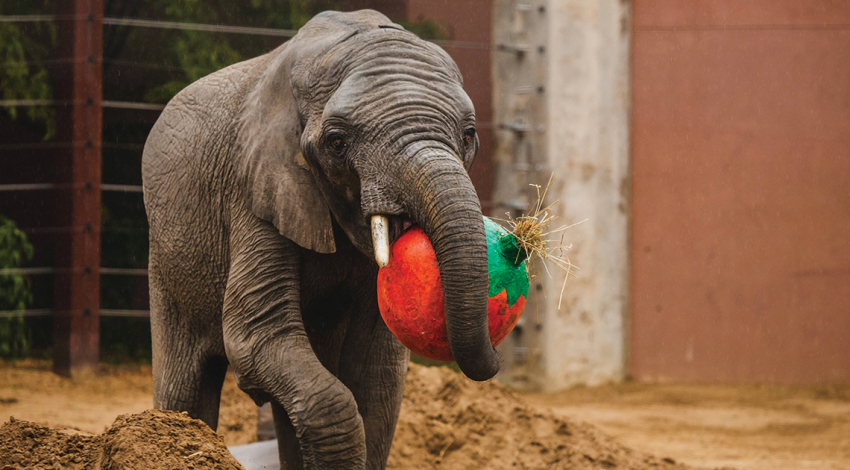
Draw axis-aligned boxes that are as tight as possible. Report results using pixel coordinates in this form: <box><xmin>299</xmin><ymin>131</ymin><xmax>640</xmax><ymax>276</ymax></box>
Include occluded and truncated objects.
<box><xmin>237</xmin><ymin>11</ymin><xmax>499</xmax><ymax>380</ymax></box>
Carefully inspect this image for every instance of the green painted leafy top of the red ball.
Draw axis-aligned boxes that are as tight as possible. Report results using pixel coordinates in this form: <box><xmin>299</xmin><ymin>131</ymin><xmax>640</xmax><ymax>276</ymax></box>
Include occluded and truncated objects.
<box><xmin>484</xmin><ymin>217</ymin><xmax>528</xmax><ymax>307</ymax></box>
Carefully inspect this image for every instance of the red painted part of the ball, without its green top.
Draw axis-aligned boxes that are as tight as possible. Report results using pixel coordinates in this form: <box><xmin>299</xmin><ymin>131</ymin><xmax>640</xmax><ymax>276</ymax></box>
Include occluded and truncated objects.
<box><xmin>378</xmin><ymin>227</ymin><xmax>525</xmax><ymax>361</ymax></box>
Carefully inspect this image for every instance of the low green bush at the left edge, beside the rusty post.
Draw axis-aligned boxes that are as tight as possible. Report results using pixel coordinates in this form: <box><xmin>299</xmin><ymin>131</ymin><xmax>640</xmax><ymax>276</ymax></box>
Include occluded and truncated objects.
<box><xmin>0</xmin><ymin>215</ymin><xmax>33</xmax><ymax>358</ymax></box>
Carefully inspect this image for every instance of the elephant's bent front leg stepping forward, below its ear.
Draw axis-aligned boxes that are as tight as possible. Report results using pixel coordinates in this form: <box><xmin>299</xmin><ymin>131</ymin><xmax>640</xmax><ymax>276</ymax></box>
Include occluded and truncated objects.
<box><xmin>223</xmin><ymin>219</ymin><xmax>366</xmax><ymax>469</ymax></box>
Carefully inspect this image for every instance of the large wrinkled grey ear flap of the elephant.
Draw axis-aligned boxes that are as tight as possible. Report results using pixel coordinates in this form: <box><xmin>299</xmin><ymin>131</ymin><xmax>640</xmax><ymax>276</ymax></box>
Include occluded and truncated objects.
<box><xmin>235</xmin><ymin>44</ymin><xmax>336</xmax><ymax>253</ymax></box>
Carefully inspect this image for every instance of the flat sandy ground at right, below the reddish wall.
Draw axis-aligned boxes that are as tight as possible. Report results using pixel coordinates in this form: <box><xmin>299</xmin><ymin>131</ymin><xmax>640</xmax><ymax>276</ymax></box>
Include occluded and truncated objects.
<box><xmin>524</xmin><ymin>383</ymin><xmax>850</xmax><ymax>470</ymax></box>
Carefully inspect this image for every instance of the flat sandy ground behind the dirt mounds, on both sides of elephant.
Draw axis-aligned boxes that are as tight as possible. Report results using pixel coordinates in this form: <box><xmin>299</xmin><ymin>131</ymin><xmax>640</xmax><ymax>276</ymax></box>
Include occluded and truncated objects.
<box><xmin>0</xmin><ymin>361</ymin><xmax>850</xmax><ymax>470</ymax></box>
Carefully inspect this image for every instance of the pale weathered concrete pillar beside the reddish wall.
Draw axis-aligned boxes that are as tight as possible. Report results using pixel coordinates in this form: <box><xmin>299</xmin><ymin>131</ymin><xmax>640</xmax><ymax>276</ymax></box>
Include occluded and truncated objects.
<box><xmin>494</xmin><ymin>0</ymin><xmax>630</xmax><ymax>391</ymax></box>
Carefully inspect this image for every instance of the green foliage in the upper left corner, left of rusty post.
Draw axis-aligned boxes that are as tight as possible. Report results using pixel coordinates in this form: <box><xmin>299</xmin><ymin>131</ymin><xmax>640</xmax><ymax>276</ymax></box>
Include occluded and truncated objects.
<box><xmin>0</xmin><ymin>0</ymin><xmax>56</xmax><ymax>140</ymax></box>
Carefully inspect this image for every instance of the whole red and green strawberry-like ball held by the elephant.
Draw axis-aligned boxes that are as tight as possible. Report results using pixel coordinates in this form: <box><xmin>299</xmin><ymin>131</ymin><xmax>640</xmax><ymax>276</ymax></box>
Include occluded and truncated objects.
<box><xmin>378</xmin><ymin>217</ymin><xmax>528</xmax><ymax>361</ymax></box>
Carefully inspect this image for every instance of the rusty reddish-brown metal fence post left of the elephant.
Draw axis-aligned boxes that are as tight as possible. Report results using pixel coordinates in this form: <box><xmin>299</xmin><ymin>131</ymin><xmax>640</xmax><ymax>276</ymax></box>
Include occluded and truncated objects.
<box><xmin>53</xmin><ymin>0</ymin><xmax>103</xmax><ymax>376</ymax></box>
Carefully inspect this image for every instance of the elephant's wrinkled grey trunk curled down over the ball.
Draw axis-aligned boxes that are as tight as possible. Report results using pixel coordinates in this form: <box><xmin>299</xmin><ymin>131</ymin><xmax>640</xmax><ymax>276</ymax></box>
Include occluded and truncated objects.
<box><xmin>403</xmin><ymin>149</ymin><xmax>499</xmax><ymax>380</ymax></box>
